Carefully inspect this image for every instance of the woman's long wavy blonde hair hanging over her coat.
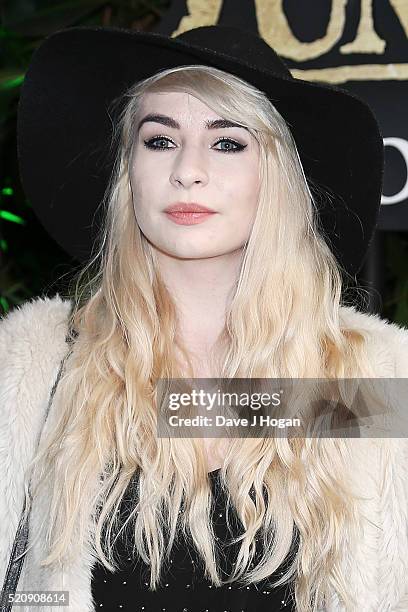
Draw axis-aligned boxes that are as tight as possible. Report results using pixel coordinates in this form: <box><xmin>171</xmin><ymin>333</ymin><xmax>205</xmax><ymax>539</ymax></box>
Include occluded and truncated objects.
<box><xmin>19</xmin><ymin>65</ymin><xmax>372</xmax><ymax>612</ymax></box>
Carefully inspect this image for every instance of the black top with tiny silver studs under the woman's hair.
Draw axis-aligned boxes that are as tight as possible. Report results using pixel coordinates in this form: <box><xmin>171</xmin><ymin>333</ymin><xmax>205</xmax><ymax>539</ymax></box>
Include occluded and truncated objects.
<box><xmin>92</xmin><ymin>469</ymin><xmax>298</xmax><ymax>612</ymax></box>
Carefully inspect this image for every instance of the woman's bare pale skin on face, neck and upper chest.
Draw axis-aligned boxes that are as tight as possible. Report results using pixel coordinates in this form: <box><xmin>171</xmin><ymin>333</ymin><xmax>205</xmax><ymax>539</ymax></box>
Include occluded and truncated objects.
<box><xmin>130</xmin><ymin>92</ymin><xmax>259</xmax><ymax>471</ymax></box>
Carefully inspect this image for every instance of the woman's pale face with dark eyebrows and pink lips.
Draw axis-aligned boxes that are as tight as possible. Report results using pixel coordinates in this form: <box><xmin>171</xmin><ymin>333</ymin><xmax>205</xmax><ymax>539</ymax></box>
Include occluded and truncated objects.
<box><xmin>130</xmin><ymin>92</ymin><xmax>259</xmax><ymax>259</ymax></box>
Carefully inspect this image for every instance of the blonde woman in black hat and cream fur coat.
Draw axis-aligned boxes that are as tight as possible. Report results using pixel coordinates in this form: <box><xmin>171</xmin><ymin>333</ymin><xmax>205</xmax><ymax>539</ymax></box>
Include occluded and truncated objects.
<box><xmin>0</xmin><ymin>27</ymin><xmax>408</xmax><ymax>612</ymax></box>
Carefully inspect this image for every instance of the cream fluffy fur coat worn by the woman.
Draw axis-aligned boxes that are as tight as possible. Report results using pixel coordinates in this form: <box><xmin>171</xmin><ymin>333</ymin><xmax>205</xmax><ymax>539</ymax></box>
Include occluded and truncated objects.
<box><xmin>0</xmin><ymin>295</ymin><xmax>408</xmax><ymax>612</ymax></box>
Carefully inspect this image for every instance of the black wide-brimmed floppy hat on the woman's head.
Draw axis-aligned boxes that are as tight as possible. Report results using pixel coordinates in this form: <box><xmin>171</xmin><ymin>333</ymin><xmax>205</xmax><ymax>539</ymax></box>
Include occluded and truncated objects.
<box><xmin>17</xmin><ymin>26</ymin><xmax>384</xmax><ymax>275</ymax></box>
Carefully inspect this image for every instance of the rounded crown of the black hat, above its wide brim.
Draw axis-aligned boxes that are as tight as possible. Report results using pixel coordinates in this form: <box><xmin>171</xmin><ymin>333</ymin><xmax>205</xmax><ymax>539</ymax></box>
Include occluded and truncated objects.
<box><xmin>174</xmin><ymin>25</ymin><xmax>293</xmax><ymax>79</ymax></box>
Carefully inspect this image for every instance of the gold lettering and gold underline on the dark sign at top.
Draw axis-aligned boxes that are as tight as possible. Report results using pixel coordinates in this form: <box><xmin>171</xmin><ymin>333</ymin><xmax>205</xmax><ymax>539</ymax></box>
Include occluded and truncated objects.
<box><xmin>171</xmin><ymin>0</ymin><xmax>408</xmax><ymax>83</ymax></box>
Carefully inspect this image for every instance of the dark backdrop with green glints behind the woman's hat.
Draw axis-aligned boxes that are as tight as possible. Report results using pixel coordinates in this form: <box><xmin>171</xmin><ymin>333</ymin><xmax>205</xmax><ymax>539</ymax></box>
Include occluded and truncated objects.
<box><xmin>0</xmin><ymin>0</ymin><xmax>408</xmax><ymax>326</ymax></box>
